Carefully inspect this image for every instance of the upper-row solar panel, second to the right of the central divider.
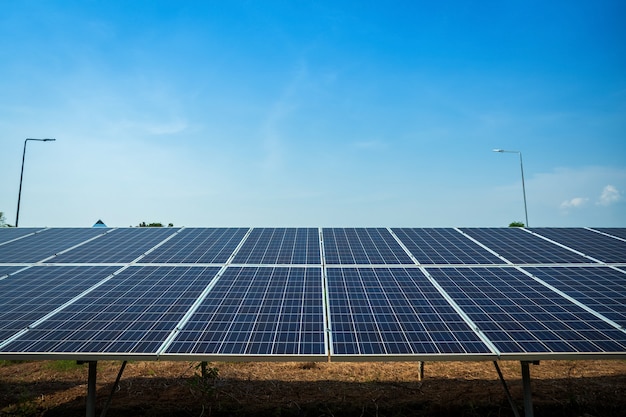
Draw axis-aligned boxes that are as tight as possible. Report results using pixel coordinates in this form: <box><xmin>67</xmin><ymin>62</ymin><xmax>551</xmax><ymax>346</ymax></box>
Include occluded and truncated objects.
<box><xmin>392</xmin><ymin>228</ymin><xmax>503</xmax><ymax>265</ymax></box>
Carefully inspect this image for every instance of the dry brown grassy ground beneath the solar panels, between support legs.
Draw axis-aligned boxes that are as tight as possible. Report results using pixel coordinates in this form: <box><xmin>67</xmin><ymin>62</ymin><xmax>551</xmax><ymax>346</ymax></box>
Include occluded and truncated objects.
<box><xmin>0</xmin><ymin>361</ymin><xmax>626</xmax><ymax>417</ymax></box>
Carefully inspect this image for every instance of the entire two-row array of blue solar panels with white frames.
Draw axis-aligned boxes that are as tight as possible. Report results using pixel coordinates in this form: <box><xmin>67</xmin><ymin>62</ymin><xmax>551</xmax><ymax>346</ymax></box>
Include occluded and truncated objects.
<box><xmin>0</xmin><ymin>228</ymin><xmax>626</xmax><ymax>361</ymax></box>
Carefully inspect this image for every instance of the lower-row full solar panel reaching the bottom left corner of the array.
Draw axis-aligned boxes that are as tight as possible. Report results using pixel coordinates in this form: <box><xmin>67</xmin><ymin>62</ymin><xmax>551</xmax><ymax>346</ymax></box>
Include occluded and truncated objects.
<box><xmin>0</xmin><ymin>266</ymin><xmax>219</xmax><ymax>354</ymax></box>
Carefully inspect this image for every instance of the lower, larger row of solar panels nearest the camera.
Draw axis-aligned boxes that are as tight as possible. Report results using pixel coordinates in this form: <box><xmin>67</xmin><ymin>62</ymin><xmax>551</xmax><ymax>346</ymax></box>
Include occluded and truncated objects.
<box><xmin>0</xmin><ymin>266</ymin><xmax>626</xmax><ymax>360</ymax></box>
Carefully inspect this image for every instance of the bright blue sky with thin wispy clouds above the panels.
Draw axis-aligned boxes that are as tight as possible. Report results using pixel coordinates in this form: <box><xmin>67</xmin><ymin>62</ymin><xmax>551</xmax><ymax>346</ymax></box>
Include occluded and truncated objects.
<box><xmin>0</xmin><ymin>0</ymin><xmax>626</xmax><ymax>227</ymax></box>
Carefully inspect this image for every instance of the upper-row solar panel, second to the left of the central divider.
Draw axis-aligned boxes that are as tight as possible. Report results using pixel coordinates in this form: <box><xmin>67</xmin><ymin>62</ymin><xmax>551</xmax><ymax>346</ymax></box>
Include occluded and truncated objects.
<box><xmin>141</xmin><ymin>228</ymin><xmax>248</xmax><ymax>263</ymax></box>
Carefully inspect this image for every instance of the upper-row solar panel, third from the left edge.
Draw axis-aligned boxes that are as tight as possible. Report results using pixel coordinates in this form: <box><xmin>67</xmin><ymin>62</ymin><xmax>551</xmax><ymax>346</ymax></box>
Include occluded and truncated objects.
<box><xmin>50</xmin><ymin>227</ymin><xmax>178</xmax><ymax>263</ymax></box>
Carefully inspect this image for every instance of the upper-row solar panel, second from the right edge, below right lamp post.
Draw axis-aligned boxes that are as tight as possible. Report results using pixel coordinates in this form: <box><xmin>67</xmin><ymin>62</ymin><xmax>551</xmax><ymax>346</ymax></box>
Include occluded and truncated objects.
<box><xmin>531</xmin><ymin>228</ymin><xmax>626</xmax><ymax>263</ymax></box>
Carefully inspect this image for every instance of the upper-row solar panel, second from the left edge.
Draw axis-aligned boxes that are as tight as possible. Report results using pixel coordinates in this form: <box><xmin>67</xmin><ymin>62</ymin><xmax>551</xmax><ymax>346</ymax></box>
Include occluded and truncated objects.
<box><xmin>0</xmin><ymin>228</ymin><xmax>106</xmax><ymax>263</ymax></box>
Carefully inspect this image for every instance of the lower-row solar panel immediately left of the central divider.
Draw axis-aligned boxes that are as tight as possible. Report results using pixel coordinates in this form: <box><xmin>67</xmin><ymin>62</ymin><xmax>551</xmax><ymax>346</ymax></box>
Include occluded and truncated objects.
<box><xmin>166</xmin><ymin>267</ymin><xmax>326</xmax><ymax>356</ymax></box>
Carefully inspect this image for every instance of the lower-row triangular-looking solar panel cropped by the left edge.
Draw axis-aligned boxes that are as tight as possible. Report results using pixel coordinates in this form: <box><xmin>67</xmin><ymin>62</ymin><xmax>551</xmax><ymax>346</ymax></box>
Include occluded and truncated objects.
<box><xmin>0</xmin><ymin>266</ymin><xmax>118</xmax><ymax>340</ymax></box>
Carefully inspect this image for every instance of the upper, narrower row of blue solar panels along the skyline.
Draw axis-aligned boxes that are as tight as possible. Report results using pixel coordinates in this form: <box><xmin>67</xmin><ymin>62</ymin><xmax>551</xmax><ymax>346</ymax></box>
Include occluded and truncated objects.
<box><xmin>0</xmin><ymin>228</ymin><xmax>626</xmax><ymax>265</ymax></box>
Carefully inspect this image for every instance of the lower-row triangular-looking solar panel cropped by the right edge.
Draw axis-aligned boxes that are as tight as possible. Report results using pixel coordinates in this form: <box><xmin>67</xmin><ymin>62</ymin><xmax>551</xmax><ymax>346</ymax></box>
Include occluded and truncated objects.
<box><xmin>524</xmin><ymin>267</ymin><xmax>626</xmax><ymax>328</ymax></box>
